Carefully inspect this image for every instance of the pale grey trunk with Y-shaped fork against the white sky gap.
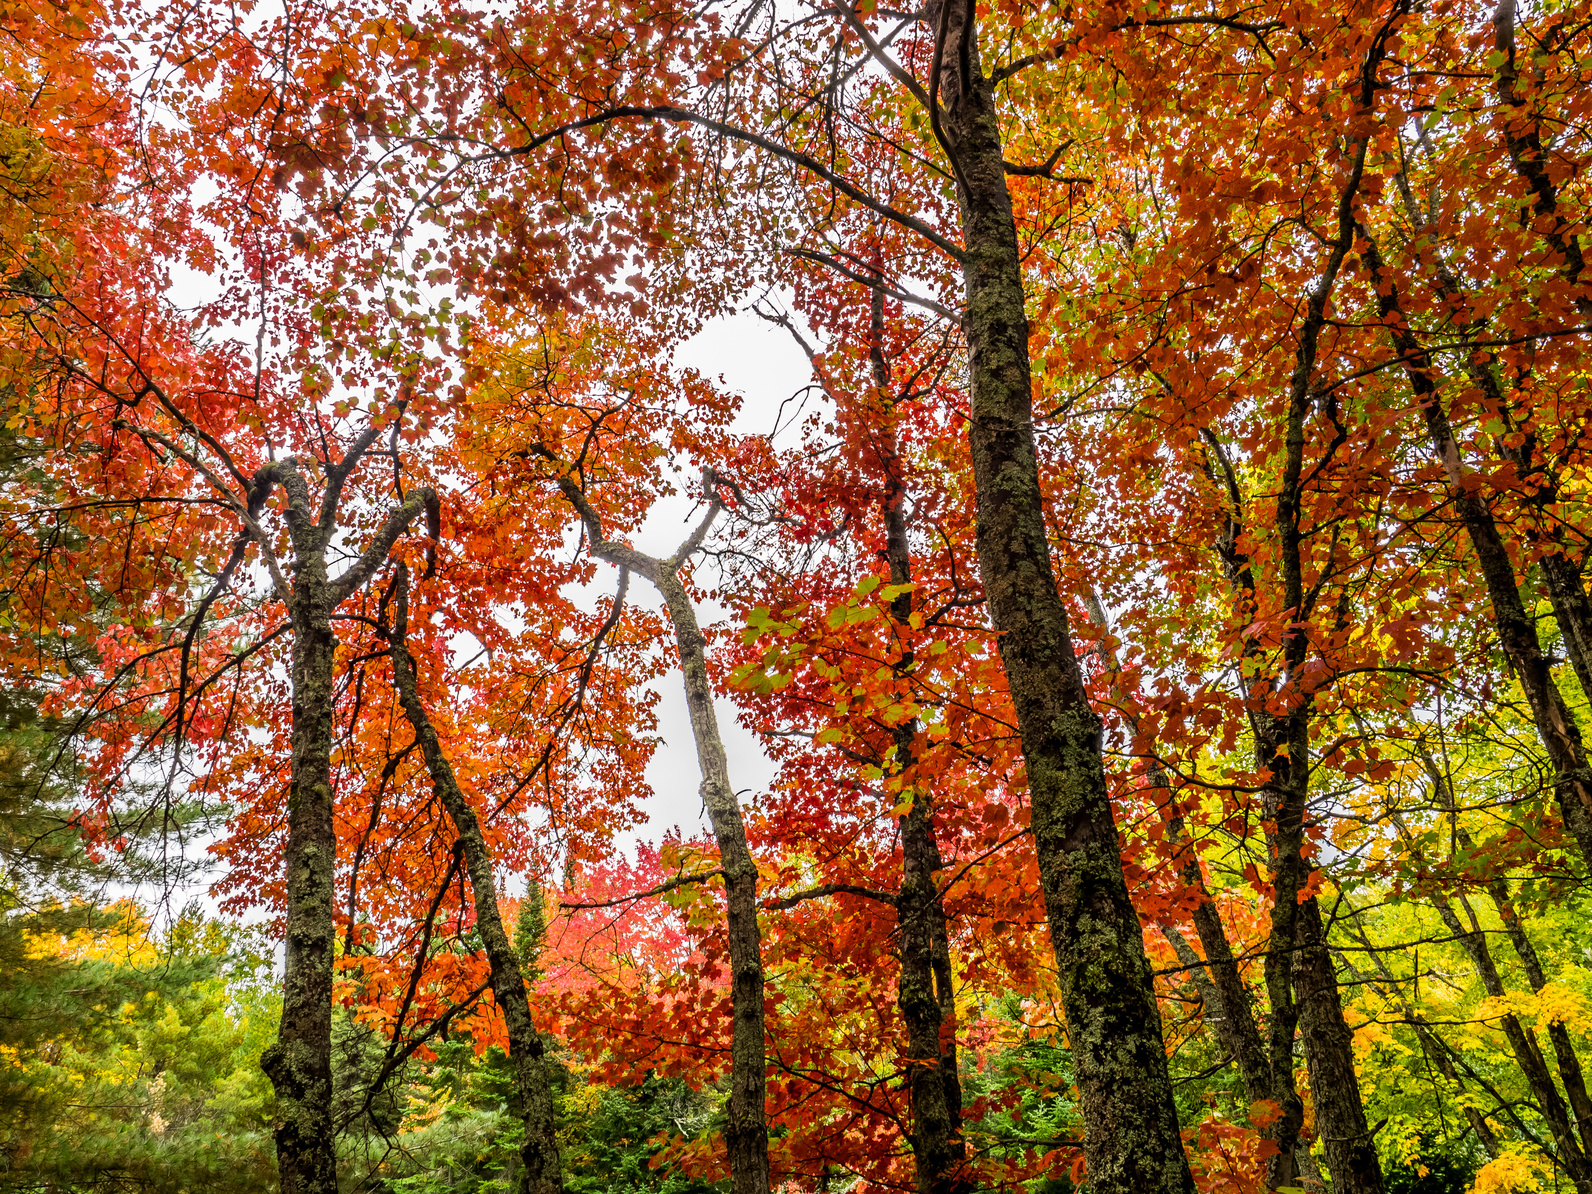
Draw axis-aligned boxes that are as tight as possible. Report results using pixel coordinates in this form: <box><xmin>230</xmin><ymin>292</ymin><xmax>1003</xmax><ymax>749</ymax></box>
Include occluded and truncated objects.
<box><xmin>541</xmin><ymin>477</ymin><xmax>769</xmax><ymax>1194</ymax></box>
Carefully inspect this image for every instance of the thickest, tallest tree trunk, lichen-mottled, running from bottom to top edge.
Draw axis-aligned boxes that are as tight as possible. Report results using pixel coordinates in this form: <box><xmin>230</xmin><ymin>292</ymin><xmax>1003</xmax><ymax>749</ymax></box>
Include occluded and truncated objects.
<box><xmin>928</xmin><ymin>0</ymin><xmax>1194</xmax><ymax>1194</ymax></box>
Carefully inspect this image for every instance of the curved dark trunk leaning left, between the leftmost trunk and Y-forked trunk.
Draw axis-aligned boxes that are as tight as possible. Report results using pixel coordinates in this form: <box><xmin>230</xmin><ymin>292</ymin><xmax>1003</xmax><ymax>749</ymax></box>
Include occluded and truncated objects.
<box><xmin>388</xmin><ymin>564</ymin><xmax>564</xmax><ymax>1194</ymax></box>
